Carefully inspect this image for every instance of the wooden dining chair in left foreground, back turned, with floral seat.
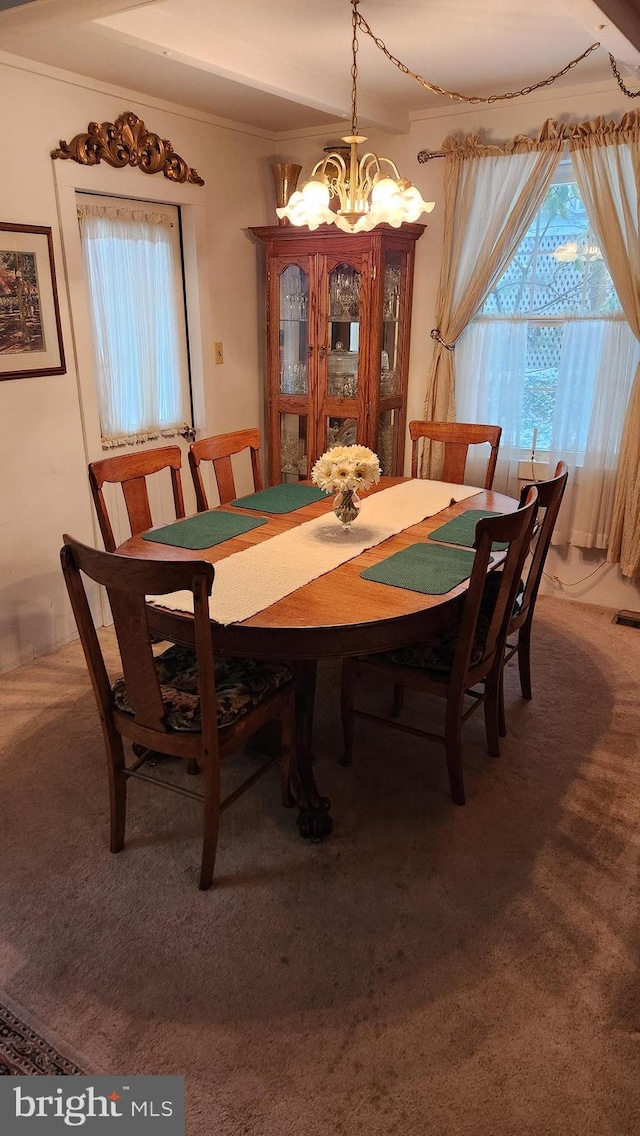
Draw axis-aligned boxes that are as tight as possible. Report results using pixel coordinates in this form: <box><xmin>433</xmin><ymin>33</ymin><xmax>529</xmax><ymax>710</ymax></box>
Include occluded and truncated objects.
<box><xmin>60</xmin><ymin>536</ymin><xmax>296</xmax><ymax>891</ymax></box>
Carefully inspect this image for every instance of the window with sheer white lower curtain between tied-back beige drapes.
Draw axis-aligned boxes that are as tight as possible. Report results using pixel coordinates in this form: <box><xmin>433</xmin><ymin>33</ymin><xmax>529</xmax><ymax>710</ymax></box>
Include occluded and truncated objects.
<box><xmin>456</xmin><ymin>162</ymin><xmax>639</xmax><ymax>463</ymax></box>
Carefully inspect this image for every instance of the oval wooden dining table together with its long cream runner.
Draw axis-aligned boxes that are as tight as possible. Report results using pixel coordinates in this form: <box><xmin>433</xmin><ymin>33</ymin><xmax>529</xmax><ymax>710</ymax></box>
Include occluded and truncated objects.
<box><xmin>116</xmin><ymin>477</ymin><xmax>518</xmax><ymax>841</ymax></box>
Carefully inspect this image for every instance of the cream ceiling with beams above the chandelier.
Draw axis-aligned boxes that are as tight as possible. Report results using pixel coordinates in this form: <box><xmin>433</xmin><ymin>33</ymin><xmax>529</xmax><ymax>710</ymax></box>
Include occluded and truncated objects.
<box><xmin>0</xmin><ymin>0</ymin><xmax>640</xmax><ymax>134</ymax></box>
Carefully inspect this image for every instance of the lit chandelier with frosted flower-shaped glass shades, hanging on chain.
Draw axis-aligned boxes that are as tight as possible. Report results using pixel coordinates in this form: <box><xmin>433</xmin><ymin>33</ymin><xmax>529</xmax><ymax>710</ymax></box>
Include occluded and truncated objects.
<box><xmin>276</xmin><ymin>0</ymin><xmax>435</xmax><ymax>233</ymax></box>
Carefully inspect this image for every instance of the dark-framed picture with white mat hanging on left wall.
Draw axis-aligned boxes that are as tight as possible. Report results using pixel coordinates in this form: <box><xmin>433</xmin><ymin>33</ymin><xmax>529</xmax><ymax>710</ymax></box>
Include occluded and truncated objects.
<box><xmin>0</xmin><ymin>222</ymin><xmax>67</xmax><ymax>379</ymax></box>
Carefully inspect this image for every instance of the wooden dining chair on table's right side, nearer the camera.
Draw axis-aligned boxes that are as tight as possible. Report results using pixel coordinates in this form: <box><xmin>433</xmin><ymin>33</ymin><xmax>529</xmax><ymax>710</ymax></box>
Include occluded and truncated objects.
<box><xmin>342</xmin><ymin>487</ymin><xmax>538</xmax><ymax>804</ymax></box>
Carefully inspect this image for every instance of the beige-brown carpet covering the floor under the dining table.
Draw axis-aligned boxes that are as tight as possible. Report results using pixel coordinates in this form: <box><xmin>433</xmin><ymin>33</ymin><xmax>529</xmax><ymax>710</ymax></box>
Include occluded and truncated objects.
<box><xmin>0</xmin><ymin>598</ymin><xmax>640</xmax><ymax>1136</ymax></box>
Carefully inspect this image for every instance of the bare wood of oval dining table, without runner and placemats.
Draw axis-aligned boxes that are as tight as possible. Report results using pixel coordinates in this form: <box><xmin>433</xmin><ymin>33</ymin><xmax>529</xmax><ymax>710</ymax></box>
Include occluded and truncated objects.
<box><xmin>117</xmin><ymin>477</ymin><xmax>517</xmax><ymax>840</ymax></box>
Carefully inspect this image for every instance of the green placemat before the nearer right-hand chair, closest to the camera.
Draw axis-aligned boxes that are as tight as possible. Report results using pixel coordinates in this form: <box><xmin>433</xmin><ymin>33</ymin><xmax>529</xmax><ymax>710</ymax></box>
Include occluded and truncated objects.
<box><xmin>360</xmin><ymin>542</ymin><xmax>475</xmax><ymax>595</ymax></box>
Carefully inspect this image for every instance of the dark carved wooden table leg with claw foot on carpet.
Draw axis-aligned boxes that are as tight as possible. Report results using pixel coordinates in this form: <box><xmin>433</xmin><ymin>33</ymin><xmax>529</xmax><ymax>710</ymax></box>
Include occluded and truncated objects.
<box><xmin>291</xmin><ymin>660</ymin><xmax>333</xmax><ymax>841</ymax></box>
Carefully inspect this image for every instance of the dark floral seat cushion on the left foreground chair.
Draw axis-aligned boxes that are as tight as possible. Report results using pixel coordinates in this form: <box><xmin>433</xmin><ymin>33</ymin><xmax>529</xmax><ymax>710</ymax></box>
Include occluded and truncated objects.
<box><xmin>111</xmin><ymin>645</ymin><xmax>292</xmax><ymax>733</ymax></box>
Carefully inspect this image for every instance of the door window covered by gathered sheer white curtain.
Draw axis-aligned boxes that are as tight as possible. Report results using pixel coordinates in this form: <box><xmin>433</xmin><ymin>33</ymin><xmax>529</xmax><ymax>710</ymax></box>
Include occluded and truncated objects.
<box><xmin>77</xmin><ymin>194</ymin><xmax>192</xmax><ymax>448</ymax></box>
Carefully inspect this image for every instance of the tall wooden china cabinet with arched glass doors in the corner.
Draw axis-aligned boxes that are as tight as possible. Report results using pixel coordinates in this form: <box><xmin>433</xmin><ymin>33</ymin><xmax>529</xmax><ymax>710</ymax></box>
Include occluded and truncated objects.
<box><xmin>250</xmin><ymin>225</ymin><xmax>424</xmax><ymax>485</ymax></box>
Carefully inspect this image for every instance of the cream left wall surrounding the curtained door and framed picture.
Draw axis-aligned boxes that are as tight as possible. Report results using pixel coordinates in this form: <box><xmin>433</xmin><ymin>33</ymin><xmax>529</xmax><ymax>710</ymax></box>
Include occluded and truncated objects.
<box><xmin>0</xmin><ymin>53</ymin><xmax>274</xmax><ymax>669</ymax></box>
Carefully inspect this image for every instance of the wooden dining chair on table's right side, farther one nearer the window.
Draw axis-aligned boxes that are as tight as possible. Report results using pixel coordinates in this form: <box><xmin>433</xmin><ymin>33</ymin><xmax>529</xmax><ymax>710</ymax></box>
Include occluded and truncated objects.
<box><xmin>500</xmin><ymin>461</ymin><xmax>568</xmax><ymax>737</ymax></box>
